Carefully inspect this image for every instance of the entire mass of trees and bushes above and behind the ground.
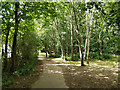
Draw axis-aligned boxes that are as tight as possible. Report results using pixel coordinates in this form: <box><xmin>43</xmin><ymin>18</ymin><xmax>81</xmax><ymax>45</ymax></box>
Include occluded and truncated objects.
<box><xmin>1</xmin><ymin>1</ymin><xmax>120</xmax><ymax>88</ymax></box>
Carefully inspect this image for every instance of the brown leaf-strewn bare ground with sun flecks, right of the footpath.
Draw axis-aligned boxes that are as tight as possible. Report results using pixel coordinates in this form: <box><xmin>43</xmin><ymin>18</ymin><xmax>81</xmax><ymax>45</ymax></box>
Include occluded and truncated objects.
<box><xmin>63</xmin><ymin>65</ymin><xmax>118</xmax><ymax>88</ymax></box>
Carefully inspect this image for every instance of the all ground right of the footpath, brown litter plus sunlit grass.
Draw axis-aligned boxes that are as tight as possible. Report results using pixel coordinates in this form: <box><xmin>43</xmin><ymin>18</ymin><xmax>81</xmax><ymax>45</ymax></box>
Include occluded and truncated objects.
<box><xmin>52</xmin><ymin>54</ymin><xmax>118</xmax><ymax>88</ymax></box>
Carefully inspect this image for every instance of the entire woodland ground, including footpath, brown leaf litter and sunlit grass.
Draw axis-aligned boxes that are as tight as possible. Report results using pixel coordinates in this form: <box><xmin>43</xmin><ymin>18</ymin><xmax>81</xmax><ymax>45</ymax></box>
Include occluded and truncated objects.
<box><xmin>10</xmin><ymin>53</ymin><xmax>118</xmax><ymax>88</ymax></box>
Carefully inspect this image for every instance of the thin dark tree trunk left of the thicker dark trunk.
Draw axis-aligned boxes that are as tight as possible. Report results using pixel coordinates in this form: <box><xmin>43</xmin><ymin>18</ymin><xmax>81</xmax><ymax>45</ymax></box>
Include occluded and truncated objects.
<box><xmin>3</xmin><ymin>24</ymin><xmax>10</xmax><ymax>70</ymax></box>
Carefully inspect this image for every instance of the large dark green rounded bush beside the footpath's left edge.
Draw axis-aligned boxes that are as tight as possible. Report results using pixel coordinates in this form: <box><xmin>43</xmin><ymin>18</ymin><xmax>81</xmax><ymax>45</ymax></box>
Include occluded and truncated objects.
<box><xmin>14</xmin><ymin>32</ymin><xmax>39</xmax><ymax>75</ymax></box>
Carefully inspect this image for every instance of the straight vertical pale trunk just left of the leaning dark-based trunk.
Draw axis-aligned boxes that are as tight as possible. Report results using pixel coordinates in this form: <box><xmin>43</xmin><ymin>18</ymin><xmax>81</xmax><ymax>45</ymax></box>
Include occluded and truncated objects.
<box><xmin>70</xmin><ymin>0</ymin><xmax>73</xmax><ymax>61</ymax></box>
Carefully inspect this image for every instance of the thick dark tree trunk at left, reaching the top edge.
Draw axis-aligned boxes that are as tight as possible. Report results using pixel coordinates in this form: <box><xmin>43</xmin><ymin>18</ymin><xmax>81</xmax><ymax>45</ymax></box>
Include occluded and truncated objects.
<box><xmin>11</xmin><ymin>2</ymin><xmax>19</xmax><ymax>72</ymax></box>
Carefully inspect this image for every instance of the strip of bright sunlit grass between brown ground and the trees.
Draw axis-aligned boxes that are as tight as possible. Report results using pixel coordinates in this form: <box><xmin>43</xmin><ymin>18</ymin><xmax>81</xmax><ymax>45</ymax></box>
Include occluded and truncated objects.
<box><xmin>48</xmin><ymin>55</ymin><xmax>119</xmax><ymax>68</ymax></box>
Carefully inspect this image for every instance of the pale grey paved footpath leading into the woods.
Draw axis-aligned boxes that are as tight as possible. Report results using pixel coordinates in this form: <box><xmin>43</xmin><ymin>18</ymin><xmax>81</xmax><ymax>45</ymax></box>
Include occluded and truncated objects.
<box><xmin>32</xmin><ymin>57</ymin><xmax>68</xmax><ymax>88</ymax></box>
